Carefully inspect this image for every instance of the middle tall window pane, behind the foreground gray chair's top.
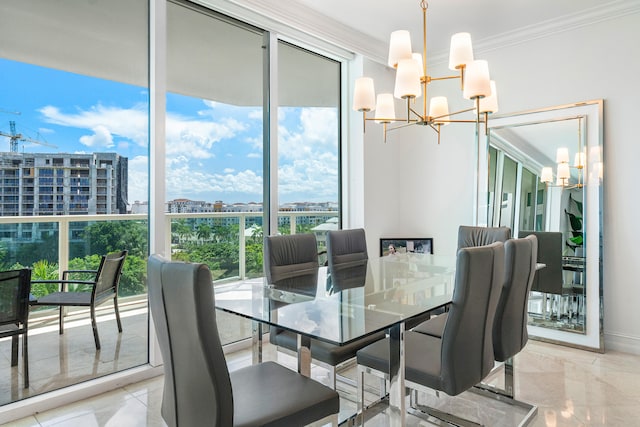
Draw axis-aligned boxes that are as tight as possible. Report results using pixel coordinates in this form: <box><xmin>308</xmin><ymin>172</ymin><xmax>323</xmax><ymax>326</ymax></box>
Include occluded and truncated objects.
<box><xmin>166</xmin><ymin>2</ymin><xmax>264</xmax><ymax>343</ymax></box>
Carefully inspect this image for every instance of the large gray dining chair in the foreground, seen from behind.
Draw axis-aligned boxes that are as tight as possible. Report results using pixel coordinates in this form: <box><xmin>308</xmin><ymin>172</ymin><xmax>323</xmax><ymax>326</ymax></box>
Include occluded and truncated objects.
<box><xmin>147</xmin><ymin>255</ymin><xmax>340</xmax><ymax>427</ymax></box>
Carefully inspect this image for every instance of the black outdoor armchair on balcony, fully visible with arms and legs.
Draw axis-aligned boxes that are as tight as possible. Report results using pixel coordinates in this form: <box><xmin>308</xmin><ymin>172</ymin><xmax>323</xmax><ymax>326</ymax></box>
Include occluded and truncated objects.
<box><xmin>31</xmin><ymin>251</ymin><xmax>127</xmax><ymax>350</ymax></box>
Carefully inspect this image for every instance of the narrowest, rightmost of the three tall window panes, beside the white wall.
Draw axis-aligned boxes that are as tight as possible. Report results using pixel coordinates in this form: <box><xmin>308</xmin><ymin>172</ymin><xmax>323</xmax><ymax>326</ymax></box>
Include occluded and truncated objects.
<box><xmin>278</xmin><ymin>41</ymin><xmax>340</xmax><ymax>252</ymax></box>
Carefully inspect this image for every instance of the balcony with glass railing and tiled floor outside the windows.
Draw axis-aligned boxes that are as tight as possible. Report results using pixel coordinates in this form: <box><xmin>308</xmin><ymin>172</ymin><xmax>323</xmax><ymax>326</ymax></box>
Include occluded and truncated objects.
<box><xmin>0</xmin><ymin>212</ymin><xmax>337</xmax><ymax>405</ymax></box>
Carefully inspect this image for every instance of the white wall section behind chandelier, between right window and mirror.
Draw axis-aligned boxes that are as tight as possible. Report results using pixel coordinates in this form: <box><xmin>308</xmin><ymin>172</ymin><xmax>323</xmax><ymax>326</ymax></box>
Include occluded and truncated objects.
<box><xmin>364</xmin><ymin>63</ymin><xmax>475</xmax><ymax>254</ymax></box>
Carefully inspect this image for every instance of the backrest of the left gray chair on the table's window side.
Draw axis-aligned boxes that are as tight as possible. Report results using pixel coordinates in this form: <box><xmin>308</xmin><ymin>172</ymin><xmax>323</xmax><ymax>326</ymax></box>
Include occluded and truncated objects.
<box><xmin>264</xmin><ymin>233</ymin><xmax>318</xmax><ymax>290</ymax></box>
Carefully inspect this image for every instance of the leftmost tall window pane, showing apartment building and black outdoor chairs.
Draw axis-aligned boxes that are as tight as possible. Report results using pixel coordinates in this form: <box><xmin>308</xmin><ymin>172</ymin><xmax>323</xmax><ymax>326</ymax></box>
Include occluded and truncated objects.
<box><xmin>0</xmin><ymin>0</ymin><xmax>149</xmax><ymax>404</ymax></box>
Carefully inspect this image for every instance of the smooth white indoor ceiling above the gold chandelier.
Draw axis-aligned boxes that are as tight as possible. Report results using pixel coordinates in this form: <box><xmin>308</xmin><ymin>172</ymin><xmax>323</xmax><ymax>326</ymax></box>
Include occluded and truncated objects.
<box><xmin>280</xmin><ymin>0</ymin><xmax>628</xmax><ymax>59</ymax></box>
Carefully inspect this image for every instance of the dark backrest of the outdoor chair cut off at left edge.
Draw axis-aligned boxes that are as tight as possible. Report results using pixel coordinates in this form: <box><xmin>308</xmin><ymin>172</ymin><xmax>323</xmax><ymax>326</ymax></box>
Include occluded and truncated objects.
<box><xmin>0</xmin><ymin>268</ymin><xmax>31</xmax><ymax>325</ymax></box>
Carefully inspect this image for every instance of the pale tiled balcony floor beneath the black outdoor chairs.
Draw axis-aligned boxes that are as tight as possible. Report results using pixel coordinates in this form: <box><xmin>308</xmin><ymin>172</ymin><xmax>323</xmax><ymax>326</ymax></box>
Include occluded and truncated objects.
<box><xmin>0</xmin><ymin>298</ymin><xmax>148</xmax><ymax>405</ymax></box>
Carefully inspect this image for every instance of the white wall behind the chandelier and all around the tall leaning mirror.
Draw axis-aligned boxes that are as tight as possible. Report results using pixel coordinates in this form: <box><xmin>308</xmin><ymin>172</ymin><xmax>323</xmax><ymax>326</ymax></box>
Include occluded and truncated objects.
<box><xmin>365</xmin><ymin>13</ymin><xmax>640</xmax><ymax>354</ymax></box>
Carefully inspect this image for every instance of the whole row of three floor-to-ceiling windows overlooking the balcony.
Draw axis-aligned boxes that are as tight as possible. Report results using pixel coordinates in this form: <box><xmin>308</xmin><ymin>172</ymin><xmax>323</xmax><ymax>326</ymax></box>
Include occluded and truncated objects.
<box><xmin>0</xmin><ymin>0</ymin><xmax>341</xmax><ymax>414</ymax></box>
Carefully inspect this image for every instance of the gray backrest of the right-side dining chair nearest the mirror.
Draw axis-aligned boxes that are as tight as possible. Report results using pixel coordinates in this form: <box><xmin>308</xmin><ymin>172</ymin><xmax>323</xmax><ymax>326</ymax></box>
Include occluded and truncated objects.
<box><xmin>493</xmin><ymin>235</ymin><xmax>538</xmax><ymax>362</ymax></box>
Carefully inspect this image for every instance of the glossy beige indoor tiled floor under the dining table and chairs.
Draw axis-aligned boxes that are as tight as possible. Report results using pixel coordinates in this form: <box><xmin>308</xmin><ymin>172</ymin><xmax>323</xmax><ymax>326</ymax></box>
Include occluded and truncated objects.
<box><xmin>3</xmin><ymin>341</ymin><xmax>640</xmax><ymax>427</ymax></box>
